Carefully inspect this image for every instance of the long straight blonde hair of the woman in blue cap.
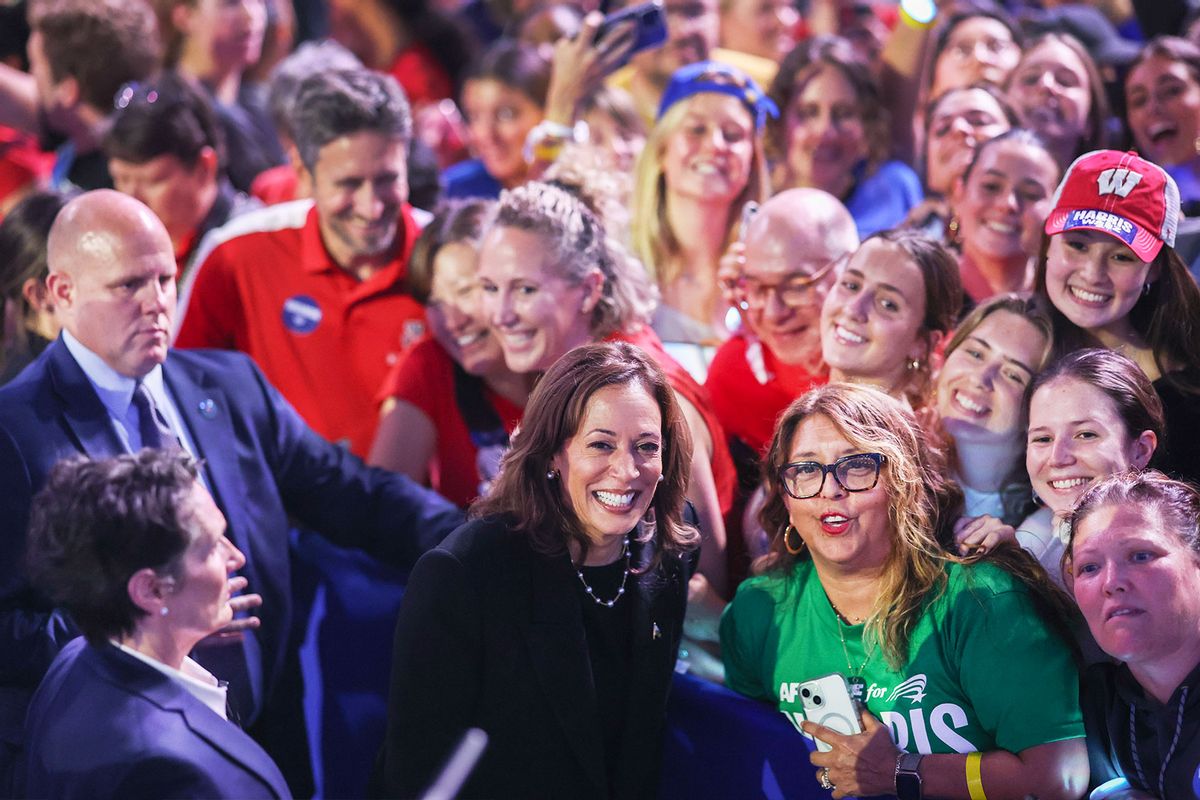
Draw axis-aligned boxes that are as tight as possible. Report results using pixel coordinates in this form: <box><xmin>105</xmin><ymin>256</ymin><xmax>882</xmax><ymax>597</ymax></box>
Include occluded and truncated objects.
<box><xmin>630</xmin><ymin>96</ymin><xmax>770</xmax><ymax>285</ymax></box>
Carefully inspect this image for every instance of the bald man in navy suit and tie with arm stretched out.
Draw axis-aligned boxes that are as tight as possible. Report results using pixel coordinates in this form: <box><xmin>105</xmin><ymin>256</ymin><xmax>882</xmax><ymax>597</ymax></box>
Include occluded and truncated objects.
<box><xmin>0</xmin><ymin>191</ymin><xmax>461</xmax><ymax>794</ymax></box>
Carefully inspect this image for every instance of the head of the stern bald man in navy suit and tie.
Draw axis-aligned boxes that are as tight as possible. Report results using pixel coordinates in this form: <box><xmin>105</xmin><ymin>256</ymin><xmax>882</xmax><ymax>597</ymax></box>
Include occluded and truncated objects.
<box><xmin>46</xmin><ymin>190</ymin><xmax>175</xmax><ymax>378</ymax></box>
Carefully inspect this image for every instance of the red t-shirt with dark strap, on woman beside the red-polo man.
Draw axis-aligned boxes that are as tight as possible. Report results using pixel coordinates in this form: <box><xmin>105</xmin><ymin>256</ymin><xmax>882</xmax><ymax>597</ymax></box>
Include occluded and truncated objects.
<box><xmin>379</xmin><ymin>338</ymin><xmax>524</xmax><ymax>509</ymax></box>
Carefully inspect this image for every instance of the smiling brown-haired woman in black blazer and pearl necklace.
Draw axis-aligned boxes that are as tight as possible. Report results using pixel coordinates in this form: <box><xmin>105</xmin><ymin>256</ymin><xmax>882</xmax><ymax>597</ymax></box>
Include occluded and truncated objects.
<box><xmin>379</xmin><ymin>343</ymin><xmax>698</xmax><ymax>799</ymax></box>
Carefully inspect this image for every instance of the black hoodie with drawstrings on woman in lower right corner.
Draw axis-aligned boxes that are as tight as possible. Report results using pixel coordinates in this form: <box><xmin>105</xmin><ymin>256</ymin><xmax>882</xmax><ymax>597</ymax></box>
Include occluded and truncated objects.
<box><xmin>1080</xmin><ymin>663</ymin><xmax>1200</xmax><ymax>799</ymax></box>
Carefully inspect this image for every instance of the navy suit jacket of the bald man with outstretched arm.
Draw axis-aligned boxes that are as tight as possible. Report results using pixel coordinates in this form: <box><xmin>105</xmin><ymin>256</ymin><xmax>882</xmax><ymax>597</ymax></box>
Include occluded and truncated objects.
<box><xmin>0</xmin><ymin>339</ymin><xmax>462</xmax><ymax>767</ymax></box>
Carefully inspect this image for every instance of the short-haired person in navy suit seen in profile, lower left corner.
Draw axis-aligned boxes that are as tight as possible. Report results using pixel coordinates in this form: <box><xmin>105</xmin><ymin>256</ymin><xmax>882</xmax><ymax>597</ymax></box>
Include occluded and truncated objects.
<box><xmin>18</xmin><ymin>449</ymin><xmax>289</xmax><ymax>800</ymax></box>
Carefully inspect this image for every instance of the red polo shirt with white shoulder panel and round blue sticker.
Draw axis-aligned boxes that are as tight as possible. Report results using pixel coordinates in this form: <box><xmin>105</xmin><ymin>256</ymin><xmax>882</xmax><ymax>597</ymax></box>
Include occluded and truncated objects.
<box><xmin>175</xmin><ymin>200</ymin><xmax>425</xmax><ymax>457</ymax></box>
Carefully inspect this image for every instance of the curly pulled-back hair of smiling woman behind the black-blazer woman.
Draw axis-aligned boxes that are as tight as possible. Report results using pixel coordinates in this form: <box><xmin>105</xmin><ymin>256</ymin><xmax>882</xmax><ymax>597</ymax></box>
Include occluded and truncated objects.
<box><xmin>487</xmin><ymin>181</ymin><xmax>655</xmax><ymax>338</ymax></box>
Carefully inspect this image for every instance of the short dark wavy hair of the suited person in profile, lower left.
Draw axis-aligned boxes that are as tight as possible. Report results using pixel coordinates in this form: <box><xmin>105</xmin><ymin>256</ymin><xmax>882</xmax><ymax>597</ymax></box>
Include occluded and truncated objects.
<box><xmin>26</xmin><ymin>449</ymin><xmax>198</xmax><ymax>644</ymax></box>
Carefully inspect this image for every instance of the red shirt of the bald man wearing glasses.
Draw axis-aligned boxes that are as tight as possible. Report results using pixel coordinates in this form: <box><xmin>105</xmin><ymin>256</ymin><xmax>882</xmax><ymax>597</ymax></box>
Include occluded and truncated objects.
<box><xmin>704</xmin><ymin>332</ymin><xmax>827</xmax><ymax>455</ymax></box>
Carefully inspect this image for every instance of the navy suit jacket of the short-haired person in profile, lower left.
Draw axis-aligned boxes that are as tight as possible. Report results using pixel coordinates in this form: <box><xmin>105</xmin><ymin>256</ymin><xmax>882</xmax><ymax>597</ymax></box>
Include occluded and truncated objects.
<box><xmin>24</xmin><ymin>638</ymin><xmax>290</xmax><ymax>800</ymax></box>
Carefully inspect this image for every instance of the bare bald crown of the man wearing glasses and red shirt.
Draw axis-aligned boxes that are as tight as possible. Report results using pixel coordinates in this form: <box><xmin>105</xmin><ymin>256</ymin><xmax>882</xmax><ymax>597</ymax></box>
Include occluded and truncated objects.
<box><xmin>746</xmin><ymin>188</ymin><xmax>858</xmax><ymax>266</ymax></box>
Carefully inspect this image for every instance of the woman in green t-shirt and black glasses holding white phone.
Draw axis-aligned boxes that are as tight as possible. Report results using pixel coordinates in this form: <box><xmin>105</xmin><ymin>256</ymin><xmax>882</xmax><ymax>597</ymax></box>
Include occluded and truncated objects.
<box><xmin>721</xmin><ymin>384</ymin><xmax>1088</xmax><ymax>800</ymax></box>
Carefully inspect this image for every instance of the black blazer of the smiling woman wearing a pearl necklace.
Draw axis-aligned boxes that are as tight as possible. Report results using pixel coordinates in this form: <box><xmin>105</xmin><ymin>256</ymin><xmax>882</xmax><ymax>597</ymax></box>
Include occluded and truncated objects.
<box><xmin>379</xmin><ymin>518</ymin><xmax>694</xmax><ymax>800</ymax></box>
